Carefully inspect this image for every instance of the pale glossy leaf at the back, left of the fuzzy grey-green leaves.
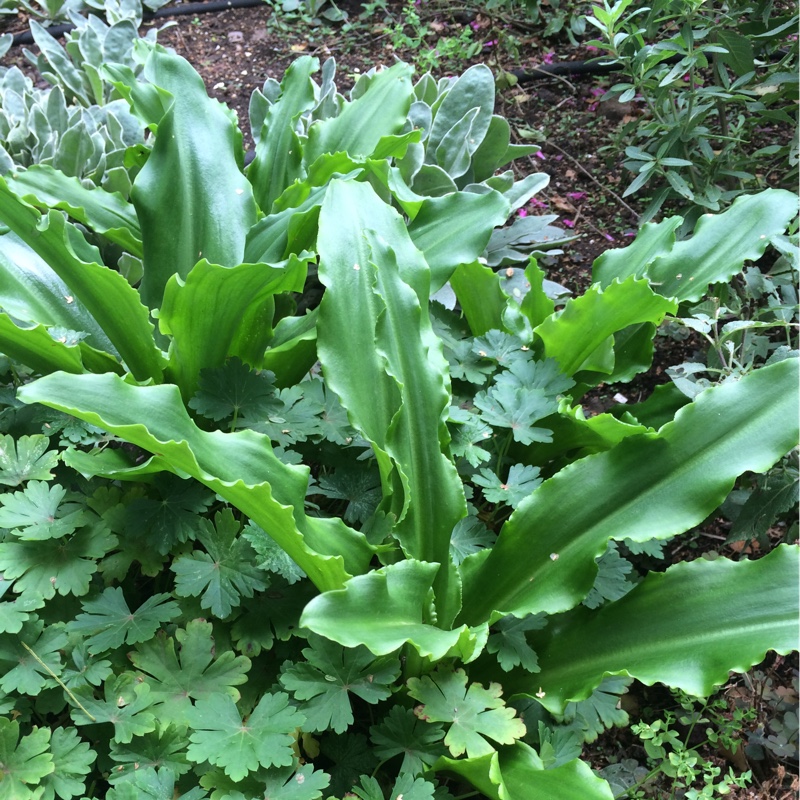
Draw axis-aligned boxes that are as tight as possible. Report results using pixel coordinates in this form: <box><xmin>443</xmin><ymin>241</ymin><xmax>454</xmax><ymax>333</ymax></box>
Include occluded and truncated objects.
<box><xmin>303</xmin><ymin>62</ymin><xmax>413</xmax><ymax>164</ymax></box>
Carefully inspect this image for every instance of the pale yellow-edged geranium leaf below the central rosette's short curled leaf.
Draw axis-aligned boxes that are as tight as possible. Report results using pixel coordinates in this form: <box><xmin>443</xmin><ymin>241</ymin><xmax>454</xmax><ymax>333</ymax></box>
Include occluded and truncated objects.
<box><xmin>408</xmin><ymin>669</ymin><xmax>525</xmax><ymax>758</ymax></box>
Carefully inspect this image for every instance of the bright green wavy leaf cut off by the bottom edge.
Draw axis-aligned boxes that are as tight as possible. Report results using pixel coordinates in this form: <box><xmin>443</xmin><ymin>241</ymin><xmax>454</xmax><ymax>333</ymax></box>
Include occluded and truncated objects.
<box><xmin>433</xmin><ymin>742</ymin><xmax>614</xmax><ymax>800</ymax></box>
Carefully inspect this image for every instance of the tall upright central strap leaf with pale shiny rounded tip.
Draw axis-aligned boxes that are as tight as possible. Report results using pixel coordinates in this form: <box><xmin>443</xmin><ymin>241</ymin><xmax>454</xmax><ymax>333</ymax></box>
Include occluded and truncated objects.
<box><xmin>317</xmin><ymin>181</ymin><xmax>466</xmax><ymax>617</ymax></box>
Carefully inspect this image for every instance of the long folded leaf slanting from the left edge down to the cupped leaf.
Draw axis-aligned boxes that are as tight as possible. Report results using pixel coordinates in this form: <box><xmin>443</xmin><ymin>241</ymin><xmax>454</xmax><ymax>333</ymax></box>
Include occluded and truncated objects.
<box><xmin>0</xmin><ymin>178</ymin><xmax>163</xmax><ymax>381</ymax></box>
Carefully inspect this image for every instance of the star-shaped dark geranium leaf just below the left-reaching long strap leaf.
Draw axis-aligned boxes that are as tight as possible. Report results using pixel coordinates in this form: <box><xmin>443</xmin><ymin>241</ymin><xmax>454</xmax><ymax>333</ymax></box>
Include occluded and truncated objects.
<box><xmin>171</xmin><ymin>508</ymin><xmax>269</xmax><ymax>619</ymax></box>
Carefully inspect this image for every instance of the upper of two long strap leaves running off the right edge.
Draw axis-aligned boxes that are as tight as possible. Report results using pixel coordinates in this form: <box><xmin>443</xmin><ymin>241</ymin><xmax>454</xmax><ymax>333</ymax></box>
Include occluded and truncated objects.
<box><xmin>459</xmin><ymin>359</ymin><xmax>798</xmax><ymax>625</ymax></box>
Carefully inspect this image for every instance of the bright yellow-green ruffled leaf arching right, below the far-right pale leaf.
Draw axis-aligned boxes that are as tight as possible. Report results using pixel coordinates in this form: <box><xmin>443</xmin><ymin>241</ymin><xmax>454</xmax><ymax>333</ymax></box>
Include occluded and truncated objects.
<box><xmin>535</xmin><ymin>278</ymin><xmax>678</xmax><ymax>375</ymax></box>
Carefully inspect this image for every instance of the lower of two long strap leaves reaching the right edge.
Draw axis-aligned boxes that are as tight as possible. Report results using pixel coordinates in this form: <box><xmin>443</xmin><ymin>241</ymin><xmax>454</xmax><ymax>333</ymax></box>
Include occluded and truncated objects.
<box><xmin>520</xmin><ymin>545</ymin><xmax>800</xmax><ymax>713</ymax></box>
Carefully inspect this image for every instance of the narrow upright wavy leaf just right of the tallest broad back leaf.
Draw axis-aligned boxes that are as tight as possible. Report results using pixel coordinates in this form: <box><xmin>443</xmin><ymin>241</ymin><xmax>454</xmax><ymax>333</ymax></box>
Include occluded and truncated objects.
<box><xmin>247</xmin><ymin>56</ymin><xmax>319</xmax><ymax>213</ymax></box>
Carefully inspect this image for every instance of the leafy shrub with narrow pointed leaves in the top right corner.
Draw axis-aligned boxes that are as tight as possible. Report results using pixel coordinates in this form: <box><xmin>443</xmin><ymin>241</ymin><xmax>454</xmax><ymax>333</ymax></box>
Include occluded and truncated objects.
<box><xmin>587</xmin><ymin>0</ymin><xmax>798</xmax><ymax>219</ymax></box>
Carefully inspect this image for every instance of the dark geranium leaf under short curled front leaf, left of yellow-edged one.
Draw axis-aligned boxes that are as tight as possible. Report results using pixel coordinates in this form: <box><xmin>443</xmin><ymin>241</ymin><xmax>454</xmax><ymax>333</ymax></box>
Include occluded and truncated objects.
<box><xmin>280</xmin><ymin>636</ymin><xmax>400</xmax><ymax>733</ymax></box>
